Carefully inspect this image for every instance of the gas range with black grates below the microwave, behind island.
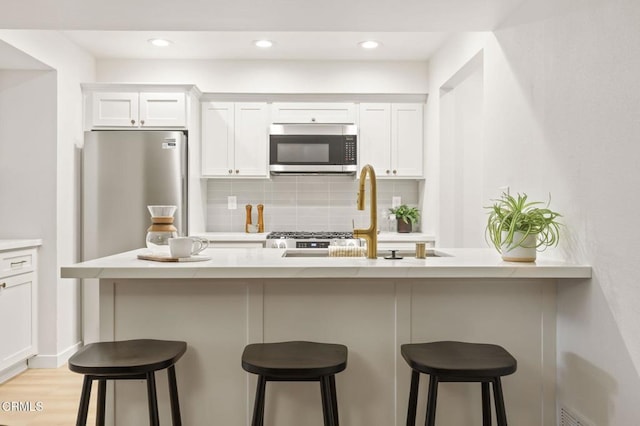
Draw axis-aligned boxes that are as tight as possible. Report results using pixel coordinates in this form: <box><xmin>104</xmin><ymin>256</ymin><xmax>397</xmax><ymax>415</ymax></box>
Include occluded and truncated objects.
<box><xmin>267</xmin><ymin>231</ymin><xmax>361</xmax><ymax>249</ymax></box>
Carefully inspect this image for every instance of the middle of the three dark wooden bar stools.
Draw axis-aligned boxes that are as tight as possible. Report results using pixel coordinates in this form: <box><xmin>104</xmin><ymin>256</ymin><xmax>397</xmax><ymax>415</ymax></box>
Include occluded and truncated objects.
<box><xmin>242</xmin><ymin>342</ymin><xmax>347</xmax><ymax>426</ymax></box>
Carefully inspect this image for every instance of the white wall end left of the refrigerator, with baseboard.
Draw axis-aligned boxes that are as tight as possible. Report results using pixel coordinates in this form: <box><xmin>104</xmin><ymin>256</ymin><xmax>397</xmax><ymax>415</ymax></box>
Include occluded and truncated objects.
<box><xmin>0</xmin><ymin>30</ymin><xmax>95</xmax><ymax>366</ymax></box>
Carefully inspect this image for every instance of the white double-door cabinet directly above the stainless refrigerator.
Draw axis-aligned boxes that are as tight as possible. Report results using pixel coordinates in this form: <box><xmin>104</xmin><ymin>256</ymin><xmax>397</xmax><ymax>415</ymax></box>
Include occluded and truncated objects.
<box><xmin>89</xmin><ymin>92</ymin><xmax>187</xmax><ymax>128</ymax></box>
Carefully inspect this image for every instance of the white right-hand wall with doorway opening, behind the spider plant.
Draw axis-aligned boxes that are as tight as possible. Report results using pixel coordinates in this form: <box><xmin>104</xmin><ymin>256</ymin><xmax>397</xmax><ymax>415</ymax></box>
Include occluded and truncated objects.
<box><xmin>427</xmin><ymin>0</ymin><xmax>640</xmax><ymax>425</ymax></box>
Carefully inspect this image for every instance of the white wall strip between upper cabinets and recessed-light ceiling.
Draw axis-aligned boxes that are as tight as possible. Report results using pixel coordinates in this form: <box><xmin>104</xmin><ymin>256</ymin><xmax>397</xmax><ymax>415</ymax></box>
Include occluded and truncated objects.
<box><xmin>97</xmin><ymin>59</ymin><xmax>428</xmax><ymax>94</ymax></box>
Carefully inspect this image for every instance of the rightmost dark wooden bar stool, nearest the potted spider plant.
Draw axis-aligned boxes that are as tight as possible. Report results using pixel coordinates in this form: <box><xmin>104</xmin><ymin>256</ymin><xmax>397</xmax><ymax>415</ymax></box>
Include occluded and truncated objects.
<box><xmin>400</xmin><ymin>342</ymin><xmax>517</xmax><ymax>426</ymax></box>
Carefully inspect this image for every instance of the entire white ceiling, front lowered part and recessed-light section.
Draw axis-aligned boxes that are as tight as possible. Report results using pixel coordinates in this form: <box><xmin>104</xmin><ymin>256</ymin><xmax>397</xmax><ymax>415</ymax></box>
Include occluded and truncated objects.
<box><xmin>0</xmin><ymin>0</ymin><xmax>525</xmax><ymax>61</ymax></box>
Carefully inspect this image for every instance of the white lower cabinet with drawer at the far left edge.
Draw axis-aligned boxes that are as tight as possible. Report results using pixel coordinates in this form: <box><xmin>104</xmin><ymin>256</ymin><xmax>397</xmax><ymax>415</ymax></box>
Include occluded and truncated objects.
<box><xmin>0</xmin><ymin>249</ymin><xmax>38</xmax><ymax>383</ymax></box>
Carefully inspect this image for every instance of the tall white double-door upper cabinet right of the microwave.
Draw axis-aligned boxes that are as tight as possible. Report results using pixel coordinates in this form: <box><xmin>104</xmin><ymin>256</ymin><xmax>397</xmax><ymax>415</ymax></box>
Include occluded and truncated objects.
<box><xmin>358</xmin><ymin>103</ymin><xmax>423</xmax><ymax>178</ymax></box>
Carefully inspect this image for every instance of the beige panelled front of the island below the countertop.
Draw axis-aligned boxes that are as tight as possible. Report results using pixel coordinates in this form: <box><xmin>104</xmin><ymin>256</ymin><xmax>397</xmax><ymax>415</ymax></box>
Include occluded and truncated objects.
<box><xmin>100</xmin><ymin>278</ymin><xmax>556</xmax><ymax>426</ymax></box>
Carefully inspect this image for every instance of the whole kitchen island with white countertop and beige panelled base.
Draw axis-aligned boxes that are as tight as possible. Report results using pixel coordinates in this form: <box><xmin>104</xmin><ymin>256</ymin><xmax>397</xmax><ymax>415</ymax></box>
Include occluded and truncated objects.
<box><xmin>61</xmin><ymin>248</ymin><xmax>591</xmax><ymax>426</ymax></box>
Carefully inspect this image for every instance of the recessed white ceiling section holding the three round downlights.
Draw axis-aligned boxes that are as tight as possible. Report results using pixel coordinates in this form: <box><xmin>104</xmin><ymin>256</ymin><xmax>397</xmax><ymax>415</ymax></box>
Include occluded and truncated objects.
<box><xmin>58</xmin><ymin>31</ymin><xmax>447</xmax><ymax>61</ymax></box>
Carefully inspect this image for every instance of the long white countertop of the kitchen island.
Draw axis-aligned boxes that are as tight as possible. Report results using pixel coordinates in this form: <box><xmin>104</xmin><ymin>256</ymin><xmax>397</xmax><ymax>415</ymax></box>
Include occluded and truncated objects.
<box><xmin>61</xmin><ymin>248</ymin><xmax>591</xmax><ymax>279</ymax></box>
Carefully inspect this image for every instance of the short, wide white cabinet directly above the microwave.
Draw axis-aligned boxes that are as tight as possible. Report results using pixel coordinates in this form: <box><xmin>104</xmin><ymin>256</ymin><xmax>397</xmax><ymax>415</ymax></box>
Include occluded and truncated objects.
<box><xmin>271</xmin><ymin>102</ymin><xmax>356</xmax><ymax>124</ymax></box>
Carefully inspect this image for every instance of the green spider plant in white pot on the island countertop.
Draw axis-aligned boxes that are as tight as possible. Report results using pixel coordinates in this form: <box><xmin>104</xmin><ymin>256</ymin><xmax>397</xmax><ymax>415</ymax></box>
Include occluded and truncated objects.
<box><xmin>485</xmin><ymin>193</ymin><xmax>561</xmax><ymax>262</ymax></box>
